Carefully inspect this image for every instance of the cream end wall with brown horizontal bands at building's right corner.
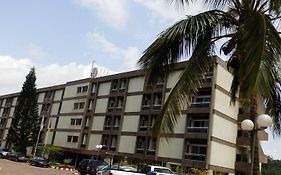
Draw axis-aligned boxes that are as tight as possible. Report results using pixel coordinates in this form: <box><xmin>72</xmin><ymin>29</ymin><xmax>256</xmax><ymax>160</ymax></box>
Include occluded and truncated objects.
<box><xmin>207</xmin><ymin>65</ymin><xmax>238</xmax><ymax>170</ymax></box>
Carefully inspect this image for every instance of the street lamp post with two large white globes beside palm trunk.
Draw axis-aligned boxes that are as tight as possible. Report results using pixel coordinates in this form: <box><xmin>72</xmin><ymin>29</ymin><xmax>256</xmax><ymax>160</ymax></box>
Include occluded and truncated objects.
<box><xmin>238</xmin><ymin>114</ymin><xmax>272</xmax><ymax>175</ymax></box>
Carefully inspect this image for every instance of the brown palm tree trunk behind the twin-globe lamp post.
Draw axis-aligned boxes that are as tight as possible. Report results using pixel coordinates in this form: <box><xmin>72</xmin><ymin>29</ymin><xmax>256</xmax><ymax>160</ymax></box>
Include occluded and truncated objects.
<box><xmin>250</xmin><ymin>96</ymin><xmax>260</xmax><ymax>175</ymax></box>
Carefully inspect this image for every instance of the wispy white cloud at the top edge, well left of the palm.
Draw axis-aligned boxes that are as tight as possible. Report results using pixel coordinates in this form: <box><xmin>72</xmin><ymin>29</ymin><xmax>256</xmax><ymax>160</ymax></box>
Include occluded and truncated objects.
<box><xmin>76</xmin><ymin>0</ymin><xmax>129</xmax><ymax>28</ymax></box>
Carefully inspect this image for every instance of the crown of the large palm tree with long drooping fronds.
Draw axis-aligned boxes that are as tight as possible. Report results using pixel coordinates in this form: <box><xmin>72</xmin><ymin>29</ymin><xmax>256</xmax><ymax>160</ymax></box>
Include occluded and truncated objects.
<box><xmin>138</xmin><ymin>0</ymin><xmax>281</xmax><ymax>174</ymax></box>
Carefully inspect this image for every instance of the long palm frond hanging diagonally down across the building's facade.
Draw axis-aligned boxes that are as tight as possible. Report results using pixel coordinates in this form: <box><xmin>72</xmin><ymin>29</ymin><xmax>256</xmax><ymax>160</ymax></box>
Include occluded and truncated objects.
<box><xmin>153</xmin><ymin>28</ymin><xmax>214</xmax><ymax>136</ymax></box>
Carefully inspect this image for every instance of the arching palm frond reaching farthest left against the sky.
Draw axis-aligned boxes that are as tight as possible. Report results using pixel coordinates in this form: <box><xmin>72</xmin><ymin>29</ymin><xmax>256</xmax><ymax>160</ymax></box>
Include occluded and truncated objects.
<box><xmin>138</xmin><ymin>10</ymin><xmax>224</xmax><ymax>84</ymax></box>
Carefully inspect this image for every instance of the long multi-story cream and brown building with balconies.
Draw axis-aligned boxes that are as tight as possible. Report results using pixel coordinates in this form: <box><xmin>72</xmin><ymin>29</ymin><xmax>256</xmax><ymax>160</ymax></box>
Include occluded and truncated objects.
<box><xmin>0</xmin><ymin>58</ymin><xmax>267</xmax><ymax>175</ymax></box>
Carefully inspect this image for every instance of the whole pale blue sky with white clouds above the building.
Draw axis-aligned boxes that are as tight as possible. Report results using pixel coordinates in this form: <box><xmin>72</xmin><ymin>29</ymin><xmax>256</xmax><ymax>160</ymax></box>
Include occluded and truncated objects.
<box><xmin>0</xmin><ymin>0</ymin><xmax>281</xmax><ymax>159</ymax></box>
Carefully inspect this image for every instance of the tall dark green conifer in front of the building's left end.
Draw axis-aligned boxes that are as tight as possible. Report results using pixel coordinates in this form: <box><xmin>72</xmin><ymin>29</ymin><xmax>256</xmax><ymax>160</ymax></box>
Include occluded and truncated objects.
<box><xmin>7</xmin><ymin>68</ymin><xmax>39</xmax><ymax>153</ymax></box>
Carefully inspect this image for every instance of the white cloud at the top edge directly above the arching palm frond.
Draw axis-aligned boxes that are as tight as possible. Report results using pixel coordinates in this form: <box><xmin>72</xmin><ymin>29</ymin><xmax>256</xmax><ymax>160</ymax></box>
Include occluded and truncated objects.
<box><xmin>134</xmin><ymin>0</ymin><xmax>204</xmax><ymax>22</ymax></box>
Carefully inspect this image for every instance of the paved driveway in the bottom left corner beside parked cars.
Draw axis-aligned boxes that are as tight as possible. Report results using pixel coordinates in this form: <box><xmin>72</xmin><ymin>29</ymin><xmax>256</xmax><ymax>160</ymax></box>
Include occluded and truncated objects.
<box><xmin>0</xmin><ymin>159</ymin><xmax>73</xmax><ymax>175</ymax></box>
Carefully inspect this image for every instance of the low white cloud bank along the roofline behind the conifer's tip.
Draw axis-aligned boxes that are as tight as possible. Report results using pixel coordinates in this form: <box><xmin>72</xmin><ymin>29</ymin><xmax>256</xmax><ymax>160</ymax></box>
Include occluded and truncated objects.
<box><xmin>0</xmin><ymin>55</ymin><xmax>114</xmax><ymax>94</ymax></box>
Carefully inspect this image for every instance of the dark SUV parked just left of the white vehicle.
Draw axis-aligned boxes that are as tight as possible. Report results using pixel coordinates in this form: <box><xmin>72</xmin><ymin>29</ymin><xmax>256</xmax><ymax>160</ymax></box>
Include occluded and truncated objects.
<box><xmin>78</xmin><ymin>159</ymin><xmax>107</xmax><ymax>175</ymax></box>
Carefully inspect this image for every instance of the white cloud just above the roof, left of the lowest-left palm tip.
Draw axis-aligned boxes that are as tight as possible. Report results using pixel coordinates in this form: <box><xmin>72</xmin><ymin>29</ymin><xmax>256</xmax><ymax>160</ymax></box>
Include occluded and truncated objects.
<box><xmin>87</xmin><ymin>32</ymin><xmax>141</xmax><ymax>70</ymax></box>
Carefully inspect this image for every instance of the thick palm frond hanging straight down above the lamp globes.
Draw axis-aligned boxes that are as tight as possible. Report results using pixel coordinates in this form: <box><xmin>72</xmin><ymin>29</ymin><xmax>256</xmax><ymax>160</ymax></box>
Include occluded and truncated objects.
<box><xmin>230</xmin><ymin>12</ymin><xmax>266</xmax><ymax>101</ymax></box>
